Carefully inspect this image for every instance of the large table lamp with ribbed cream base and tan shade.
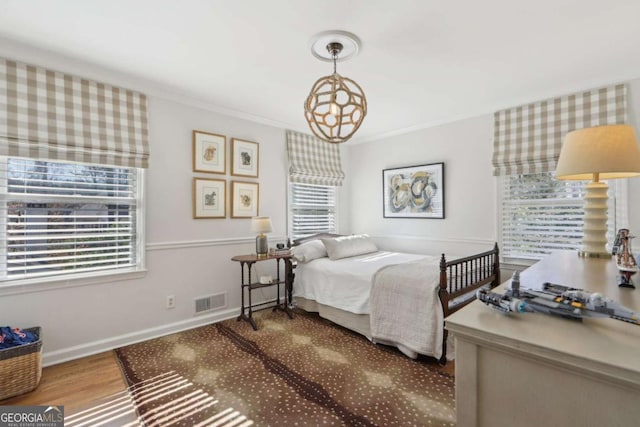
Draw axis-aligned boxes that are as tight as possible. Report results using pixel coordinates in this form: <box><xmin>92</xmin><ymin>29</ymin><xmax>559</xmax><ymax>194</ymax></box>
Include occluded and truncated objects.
<box><xmin>556</xmin><ymin>125</ymin><xmax>640</xmax><ymax>258</ymax></box>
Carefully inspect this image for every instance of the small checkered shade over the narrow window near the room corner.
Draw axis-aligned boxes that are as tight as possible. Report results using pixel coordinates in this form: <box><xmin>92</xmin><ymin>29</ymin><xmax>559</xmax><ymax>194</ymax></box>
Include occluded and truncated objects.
<box><xmin>287</xmin><ymin>130</ymin><xmax>344</xmax><ymax>186</ymax></box>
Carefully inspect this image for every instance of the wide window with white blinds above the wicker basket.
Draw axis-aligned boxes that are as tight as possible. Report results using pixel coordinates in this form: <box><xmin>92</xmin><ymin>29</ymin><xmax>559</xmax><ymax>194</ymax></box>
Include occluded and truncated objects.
<box><xmin>0</xmin><ymin>157</ymin><xmax>143</xmax><ymax>283</ymax></box>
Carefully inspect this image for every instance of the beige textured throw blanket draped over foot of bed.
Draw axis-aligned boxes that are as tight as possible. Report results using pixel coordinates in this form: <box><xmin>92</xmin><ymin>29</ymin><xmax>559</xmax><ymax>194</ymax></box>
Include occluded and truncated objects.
<box><xmin>370</xmin><ymin>256</ymin><xmax>444</xmax><ymax>358</ymax></box>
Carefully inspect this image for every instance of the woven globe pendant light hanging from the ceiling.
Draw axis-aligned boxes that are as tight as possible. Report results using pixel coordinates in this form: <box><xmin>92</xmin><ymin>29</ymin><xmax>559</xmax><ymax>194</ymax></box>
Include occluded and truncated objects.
<box><xmin>304</xmin><ymin>34</ymin><xmax>367</xmax><ymax>143</ymax></box>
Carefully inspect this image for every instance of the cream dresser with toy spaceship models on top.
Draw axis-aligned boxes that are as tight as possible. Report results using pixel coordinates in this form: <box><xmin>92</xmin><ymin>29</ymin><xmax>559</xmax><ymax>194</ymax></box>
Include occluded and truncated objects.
<box><xmin>446</xmin><ymin>252</ymin><xmax>640</xmax><ymax>427</ymax></box>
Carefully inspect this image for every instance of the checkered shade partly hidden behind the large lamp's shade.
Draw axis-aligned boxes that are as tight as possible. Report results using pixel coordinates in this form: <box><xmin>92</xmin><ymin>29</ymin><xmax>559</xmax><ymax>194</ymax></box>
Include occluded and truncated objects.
<box><xmin>493</xmin><ymin>84</ymin><xmax>627</xmax><ymax>175</ymax></box>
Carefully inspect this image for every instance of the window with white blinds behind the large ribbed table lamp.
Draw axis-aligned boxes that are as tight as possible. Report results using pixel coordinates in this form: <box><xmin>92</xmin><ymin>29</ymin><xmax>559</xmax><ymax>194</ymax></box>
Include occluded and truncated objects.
<box><xmin>501</xmin><ymin>172</ymin><xmax>616</xmax><ymax>260</ymax></box>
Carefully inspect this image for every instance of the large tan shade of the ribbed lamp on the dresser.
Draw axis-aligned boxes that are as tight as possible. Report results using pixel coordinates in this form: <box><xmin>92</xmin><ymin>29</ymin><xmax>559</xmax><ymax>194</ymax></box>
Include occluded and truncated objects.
<box><xmin>556</xmin><ymin>125</ymin><xmax>640</xmax><ymax>180</ymax></box>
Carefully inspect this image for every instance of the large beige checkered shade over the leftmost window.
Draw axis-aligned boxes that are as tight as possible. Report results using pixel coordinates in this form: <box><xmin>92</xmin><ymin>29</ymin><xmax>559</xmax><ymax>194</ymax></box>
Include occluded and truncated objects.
<box><xmin>0</xmin><ymin>58</ymin><xmax>149</xmax><ymax>168</ymax></box>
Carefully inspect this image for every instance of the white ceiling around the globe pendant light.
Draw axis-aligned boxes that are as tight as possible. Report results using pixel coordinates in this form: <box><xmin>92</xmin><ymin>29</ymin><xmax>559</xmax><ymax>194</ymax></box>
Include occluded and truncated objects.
<box><xmin>0</xmin><ymin>0</ymin><xmax>640</xmax><ymax>141</ymax></box>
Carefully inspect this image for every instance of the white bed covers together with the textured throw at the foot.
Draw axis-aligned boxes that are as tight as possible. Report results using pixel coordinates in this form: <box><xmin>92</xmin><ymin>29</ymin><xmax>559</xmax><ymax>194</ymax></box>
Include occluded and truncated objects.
<box><xmin>294</xmin><ymin>251</ymin><xmax>444</xmax><ymax>358</ymax></box>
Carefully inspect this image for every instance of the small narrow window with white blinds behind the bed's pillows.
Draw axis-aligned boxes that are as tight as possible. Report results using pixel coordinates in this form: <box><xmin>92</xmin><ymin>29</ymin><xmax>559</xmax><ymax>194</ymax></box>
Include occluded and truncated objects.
<box><xmin>288</xmin><ymin>183</ymin><xmax>337</xmax><ymax>239</ymax></box>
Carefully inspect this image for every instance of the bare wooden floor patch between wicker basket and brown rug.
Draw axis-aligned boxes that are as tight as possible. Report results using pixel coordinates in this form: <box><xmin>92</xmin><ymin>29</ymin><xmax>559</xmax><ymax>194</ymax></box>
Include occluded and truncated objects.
<box><xmin>0</xmin><ymin>351</ymin><xmax>127</xmax><ymax>416</ymax></box>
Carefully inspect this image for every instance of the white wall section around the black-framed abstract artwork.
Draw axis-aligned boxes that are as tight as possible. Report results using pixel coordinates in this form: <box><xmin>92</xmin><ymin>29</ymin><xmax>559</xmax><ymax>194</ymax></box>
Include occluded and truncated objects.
<box><xmin>348</xmin><ymin>115</ymin><xmax>497</xmax><ymax>255</ymax></box>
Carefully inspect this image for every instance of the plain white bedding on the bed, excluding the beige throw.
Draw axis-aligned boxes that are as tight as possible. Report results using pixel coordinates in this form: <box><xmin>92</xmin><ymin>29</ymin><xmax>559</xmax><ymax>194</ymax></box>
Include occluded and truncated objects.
<box><xmin>293</xmin><ymin>251</ymin><xmax>427</xmax><ymax>314</ymax></box>
